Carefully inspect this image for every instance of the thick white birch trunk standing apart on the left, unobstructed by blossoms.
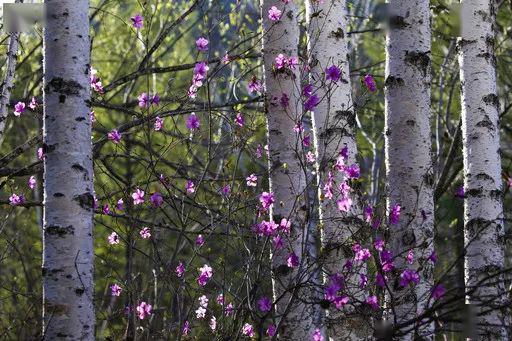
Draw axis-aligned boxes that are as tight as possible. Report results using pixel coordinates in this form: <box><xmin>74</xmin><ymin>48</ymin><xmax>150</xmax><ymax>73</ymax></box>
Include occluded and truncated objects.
<box><xmin>43</xmin><ymin>0</ymin><xmax>95</xmax><ymax>340</ymax></box>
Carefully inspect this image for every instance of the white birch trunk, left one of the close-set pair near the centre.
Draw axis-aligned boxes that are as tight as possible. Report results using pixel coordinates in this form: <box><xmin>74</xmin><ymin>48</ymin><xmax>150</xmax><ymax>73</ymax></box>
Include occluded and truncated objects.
<box><xmin>261</xmin><ymin>0</ymin><xmax>313</xmax><ymax>340</ymax></box>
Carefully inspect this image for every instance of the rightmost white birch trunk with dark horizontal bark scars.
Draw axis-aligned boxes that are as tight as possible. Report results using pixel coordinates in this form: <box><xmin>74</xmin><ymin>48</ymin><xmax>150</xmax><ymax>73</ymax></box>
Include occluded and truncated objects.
<box><xmin>458</xmin><ymin>0</ymin><xmax>510</xmax><ymax>340</ymax></box>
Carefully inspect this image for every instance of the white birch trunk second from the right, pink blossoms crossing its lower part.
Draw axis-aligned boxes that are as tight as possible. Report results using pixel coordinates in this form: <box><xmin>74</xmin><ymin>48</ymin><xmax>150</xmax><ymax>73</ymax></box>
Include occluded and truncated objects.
<box><xmin>385</xmin><ymin>0</ymin><xmax>434</xmax><ymax>339</ymax></box>
